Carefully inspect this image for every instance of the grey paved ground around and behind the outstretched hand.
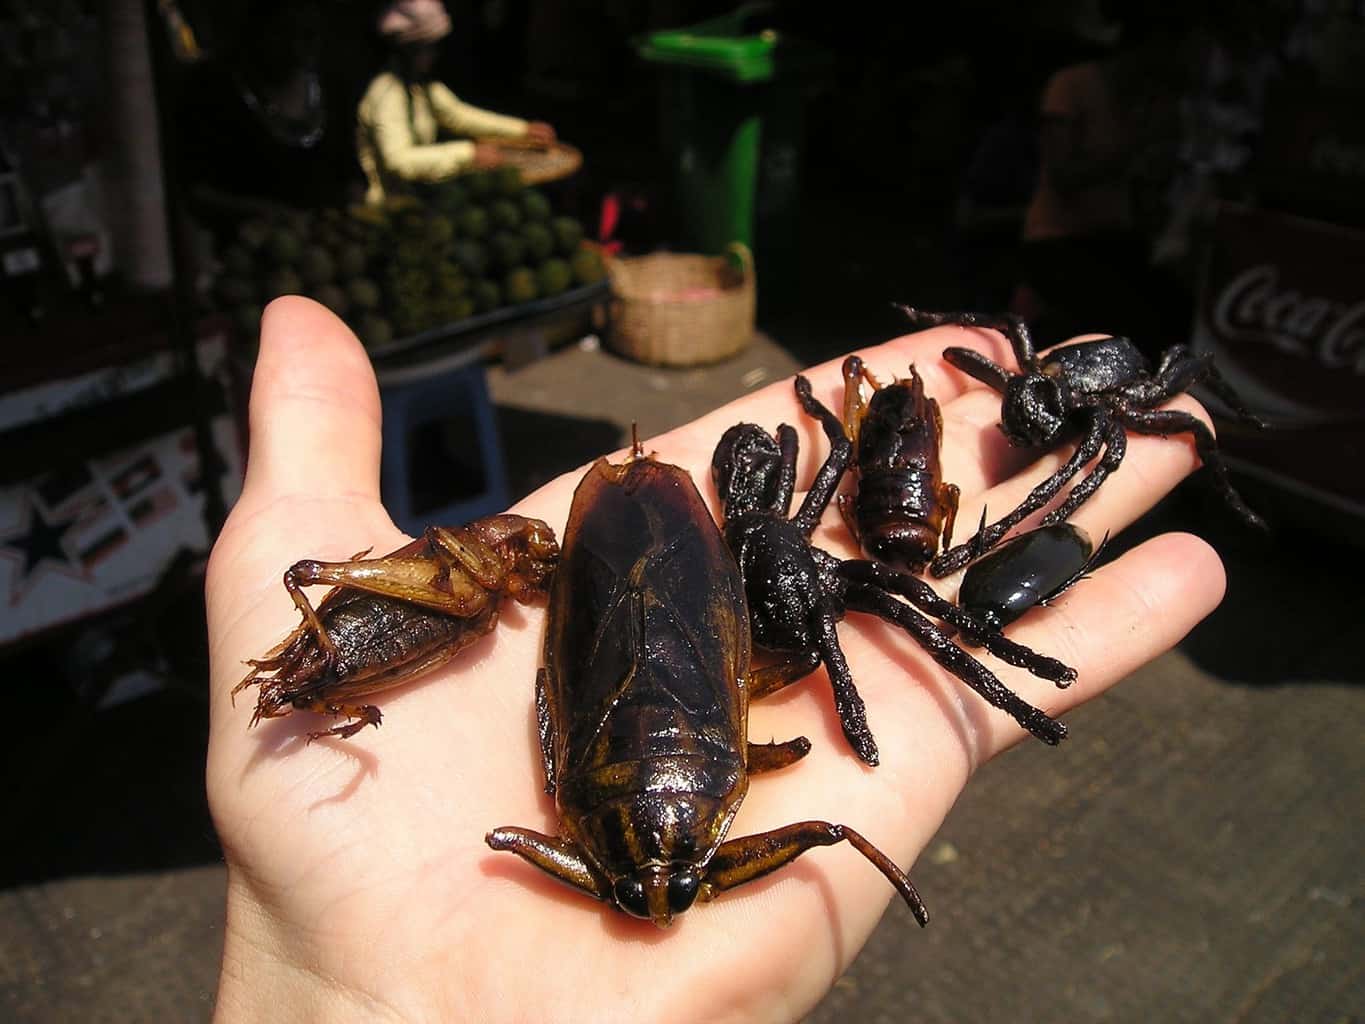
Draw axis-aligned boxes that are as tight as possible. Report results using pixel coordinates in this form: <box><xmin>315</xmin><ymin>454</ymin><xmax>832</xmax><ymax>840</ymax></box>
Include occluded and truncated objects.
<box><xmin>0</xmin><ymin>325</ymin><xmax>1365</xmax><ymax>1024</ymax></box>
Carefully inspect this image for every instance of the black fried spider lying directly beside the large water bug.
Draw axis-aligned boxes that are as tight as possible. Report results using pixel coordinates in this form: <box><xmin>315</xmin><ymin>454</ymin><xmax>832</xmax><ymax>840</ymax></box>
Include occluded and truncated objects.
<box><xmin>711</xmin><ymin>377</ymin><xmax>1076</xmax><ymax>765</ymax></box>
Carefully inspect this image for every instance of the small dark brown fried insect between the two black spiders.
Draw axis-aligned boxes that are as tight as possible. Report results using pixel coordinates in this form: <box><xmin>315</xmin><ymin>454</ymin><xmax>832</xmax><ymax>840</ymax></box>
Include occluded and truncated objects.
<box><xmin>838</xmin><ymin>355</ymin><xmax>958</xmax><ymax>572</ymax></box>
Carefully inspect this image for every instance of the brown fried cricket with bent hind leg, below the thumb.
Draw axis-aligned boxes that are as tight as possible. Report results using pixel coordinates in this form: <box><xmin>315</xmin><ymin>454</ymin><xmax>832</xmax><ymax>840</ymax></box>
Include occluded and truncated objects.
<box><xmin>232</xmin><ymin>515</ymin><xmax>560</xmax><ymax>740</ymax></box>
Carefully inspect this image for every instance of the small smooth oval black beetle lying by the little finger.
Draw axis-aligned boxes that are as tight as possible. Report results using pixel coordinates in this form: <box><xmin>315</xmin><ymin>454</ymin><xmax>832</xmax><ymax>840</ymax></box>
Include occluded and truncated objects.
<box><xmin>957</xmin><ymin>523</ymin><xmax>1104</xmax><ymax>629</ymax></box>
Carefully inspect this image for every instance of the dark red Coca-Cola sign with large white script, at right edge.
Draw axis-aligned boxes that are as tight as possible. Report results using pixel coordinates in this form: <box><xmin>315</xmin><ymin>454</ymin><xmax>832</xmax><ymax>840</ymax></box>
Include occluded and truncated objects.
<box><xmin>1196</xmin><ymin>208</ymin><xmax>1365</xmax><ymax>426</ymax></box>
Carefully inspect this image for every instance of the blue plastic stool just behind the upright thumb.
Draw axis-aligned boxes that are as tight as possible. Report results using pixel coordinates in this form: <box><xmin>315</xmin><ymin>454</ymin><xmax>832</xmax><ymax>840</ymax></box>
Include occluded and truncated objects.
<box><xmin>379</xmin><ymin>360</ymin><xmax>511</xmax><ymax>537</ymax></box>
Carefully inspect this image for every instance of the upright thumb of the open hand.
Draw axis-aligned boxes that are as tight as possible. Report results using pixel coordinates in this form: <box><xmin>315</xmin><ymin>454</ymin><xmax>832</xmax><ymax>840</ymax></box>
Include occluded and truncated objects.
<box><xmin>243</xmin><ymin>296</ymin><xmax>381</xmax><ymax>502</ymax></box>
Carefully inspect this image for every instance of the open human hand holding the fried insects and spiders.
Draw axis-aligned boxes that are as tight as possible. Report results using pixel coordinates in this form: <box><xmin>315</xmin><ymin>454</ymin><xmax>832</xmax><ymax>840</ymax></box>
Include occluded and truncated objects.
<box><xmin>207</xmin><ymin>298</ymin><xmax>1223</xmax><ymax>1021</ymax></box>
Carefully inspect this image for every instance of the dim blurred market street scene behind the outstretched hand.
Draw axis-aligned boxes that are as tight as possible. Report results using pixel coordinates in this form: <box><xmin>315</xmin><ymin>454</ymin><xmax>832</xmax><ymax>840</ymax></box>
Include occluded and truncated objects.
<box><xmin>0</xmin><ymin>0</ymin><xmax>1365</xmax><ymax>1021</ymax></box>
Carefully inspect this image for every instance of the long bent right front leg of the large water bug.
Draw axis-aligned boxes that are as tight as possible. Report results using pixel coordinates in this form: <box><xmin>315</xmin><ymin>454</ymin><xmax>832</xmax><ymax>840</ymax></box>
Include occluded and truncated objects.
<box><xmin>698</xmin><ymin>822</ymin><xmax>930</xmax><ymax>927</ymax></box>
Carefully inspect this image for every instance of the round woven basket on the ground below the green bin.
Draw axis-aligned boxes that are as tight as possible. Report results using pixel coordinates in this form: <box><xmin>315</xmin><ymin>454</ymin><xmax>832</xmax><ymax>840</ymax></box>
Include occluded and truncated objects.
<box><xmin>606</xmin><ymin>242</ymin><xmax>755</xmax><ymax>366</ymax></box>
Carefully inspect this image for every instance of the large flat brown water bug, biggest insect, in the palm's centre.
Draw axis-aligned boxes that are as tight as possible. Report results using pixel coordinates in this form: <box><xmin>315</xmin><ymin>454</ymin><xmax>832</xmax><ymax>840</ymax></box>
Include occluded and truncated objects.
<box><xmin>487</xmin><ymin>453</ymin><xmax>928</xmax><ymax>927</ymax></box>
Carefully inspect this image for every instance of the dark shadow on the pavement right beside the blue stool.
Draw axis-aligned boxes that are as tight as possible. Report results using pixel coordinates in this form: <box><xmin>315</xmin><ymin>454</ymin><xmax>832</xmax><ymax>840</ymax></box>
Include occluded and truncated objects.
<box><xmin>497</xmin><ymin>406</ymin><xmax>628</xmax><ymax>501</ymax></box>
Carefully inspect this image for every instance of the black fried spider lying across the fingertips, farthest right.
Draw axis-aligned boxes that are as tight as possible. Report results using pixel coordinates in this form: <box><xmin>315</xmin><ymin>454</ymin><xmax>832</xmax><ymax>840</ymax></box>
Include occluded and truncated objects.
<box><xmin>901</xmin><ymin>306</ymin><xmax>1265</xmax><ymax>578</ymax></box>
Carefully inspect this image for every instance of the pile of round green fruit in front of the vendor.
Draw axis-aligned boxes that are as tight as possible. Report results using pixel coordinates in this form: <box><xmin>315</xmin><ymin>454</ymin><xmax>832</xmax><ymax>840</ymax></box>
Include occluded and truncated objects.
<box><xmin>214</xmin><ymin>167</ymin><xmax>605</xmax><ymax>345</ymax></box>
